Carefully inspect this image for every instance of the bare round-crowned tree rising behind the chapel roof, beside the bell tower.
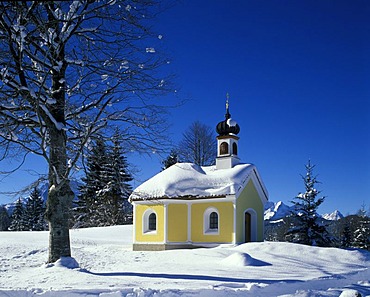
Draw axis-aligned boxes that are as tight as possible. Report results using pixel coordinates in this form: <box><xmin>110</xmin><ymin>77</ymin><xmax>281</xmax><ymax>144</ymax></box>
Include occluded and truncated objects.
<box><xmin>178</xmin><ymin>121</ymin><xmax>217</xmax><ymax>166</ymax></box>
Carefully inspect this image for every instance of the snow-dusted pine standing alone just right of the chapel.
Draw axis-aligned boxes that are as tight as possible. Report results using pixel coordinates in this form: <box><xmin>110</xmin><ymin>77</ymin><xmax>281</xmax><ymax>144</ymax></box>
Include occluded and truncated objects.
<box><xmin>286</xmin><ymin>160</ymin><xmax>332</xmax><ymax>246</ymax></box>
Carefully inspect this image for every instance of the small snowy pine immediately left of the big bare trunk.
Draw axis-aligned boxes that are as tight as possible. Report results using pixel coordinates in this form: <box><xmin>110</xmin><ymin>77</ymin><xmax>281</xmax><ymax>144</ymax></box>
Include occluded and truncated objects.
<box><xmin>24</xmin><ymin>187</ymin><xmax>46</xmax><ymax>231</ymax></box>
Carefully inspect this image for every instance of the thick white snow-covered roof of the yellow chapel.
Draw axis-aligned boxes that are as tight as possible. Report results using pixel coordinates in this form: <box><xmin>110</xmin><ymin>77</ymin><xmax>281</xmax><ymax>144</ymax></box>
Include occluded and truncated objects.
<box><xmin>130</xmin><ymin>163</ymin><xmax>263</xmax><ymax>201</ymax></box>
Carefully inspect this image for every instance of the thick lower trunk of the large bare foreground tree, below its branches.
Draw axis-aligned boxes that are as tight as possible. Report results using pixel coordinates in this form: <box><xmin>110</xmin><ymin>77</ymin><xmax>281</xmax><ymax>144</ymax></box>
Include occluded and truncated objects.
<box><xmin>46</xmin><ymin>127</ymin><xmax>74</xmax><ymax>263</ymax></box>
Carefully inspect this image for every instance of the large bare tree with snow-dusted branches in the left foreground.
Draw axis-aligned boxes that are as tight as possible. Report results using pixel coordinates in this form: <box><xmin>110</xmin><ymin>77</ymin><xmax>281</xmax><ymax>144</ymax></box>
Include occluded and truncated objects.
<box><xmin>0</xmin><ymin>0</ymin><xmax>170</xmax><ymax>262</ymax></box>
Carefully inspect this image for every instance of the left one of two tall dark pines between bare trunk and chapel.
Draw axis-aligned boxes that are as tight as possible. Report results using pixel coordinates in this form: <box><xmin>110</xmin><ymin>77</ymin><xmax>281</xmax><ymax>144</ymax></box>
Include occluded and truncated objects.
<box><xmin>74</xmin><ymin>138</ymin><xmax>108</xmax><ymax>228</ymax></box>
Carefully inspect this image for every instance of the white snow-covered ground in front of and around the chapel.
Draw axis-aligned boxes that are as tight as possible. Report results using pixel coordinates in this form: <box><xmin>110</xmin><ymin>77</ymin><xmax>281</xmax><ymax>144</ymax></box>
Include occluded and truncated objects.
<box><xmin>0</xmin><ymin>226</ymin><xmax>370</xmax><ymax>297</ymax></box>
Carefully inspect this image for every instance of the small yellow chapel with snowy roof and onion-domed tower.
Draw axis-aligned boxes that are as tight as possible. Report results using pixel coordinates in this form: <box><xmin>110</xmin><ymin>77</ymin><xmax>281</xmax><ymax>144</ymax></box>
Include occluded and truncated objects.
<box><xmin>129</xmin><ymin>98</ymin><xmax>268</xmax><ymax>250</ymax></box>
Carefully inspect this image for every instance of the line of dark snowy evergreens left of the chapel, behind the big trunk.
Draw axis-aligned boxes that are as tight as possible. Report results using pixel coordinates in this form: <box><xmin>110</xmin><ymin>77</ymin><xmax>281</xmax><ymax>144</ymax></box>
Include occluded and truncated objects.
<box><xmin>0</xmin><ymin>131</ymin><xmax>133</xmax><ymax>231</ymax></box>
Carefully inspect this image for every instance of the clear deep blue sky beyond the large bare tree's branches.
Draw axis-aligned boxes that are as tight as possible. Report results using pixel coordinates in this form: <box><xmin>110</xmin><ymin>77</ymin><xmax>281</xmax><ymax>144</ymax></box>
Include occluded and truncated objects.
<box><xmin>0</xmin><ymin>0</ymin><xmax>370</xmax><ymax>214</ymax></box>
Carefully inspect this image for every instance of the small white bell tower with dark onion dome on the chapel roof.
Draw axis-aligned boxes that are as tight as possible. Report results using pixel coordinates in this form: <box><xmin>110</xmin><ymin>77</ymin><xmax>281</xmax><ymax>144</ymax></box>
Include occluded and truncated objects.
<box><xmin>216</xmin><ymin>94</ymin><xmax>240</xmax><ymax>169</ymax></box>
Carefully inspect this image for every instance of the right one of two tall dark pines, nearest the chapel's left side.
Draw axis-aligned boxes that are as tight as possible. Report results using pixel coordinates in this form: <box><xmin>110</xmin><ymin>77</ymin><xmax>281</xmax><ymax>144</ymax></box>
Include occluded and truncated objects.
<box><xmin>102</xmin><ymin>130</ymin><xmax>133</xmax><ymax>225</ymax></box>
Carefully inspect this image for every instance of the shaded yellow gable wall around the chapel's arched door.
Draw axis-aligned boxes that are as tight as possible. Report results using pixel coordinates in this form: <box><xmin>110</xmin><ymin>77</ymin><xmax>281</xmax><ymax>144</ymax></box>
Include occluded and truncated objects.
<box><xmin>236</xmin><ymin>179</ymin><xmax>264</xmax><ymax>243</ymax></box>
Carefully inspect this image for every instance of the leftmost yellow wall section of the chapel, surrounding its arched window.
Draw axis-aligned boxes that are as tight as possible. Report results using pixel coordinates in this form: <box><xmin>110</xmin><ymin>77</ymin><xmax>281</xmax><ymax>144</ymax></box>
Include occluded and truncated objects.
<box><xmin>134</xmin><ymin>202</ymin><xmax>164</xmax><ymax>243</ymax></box>
